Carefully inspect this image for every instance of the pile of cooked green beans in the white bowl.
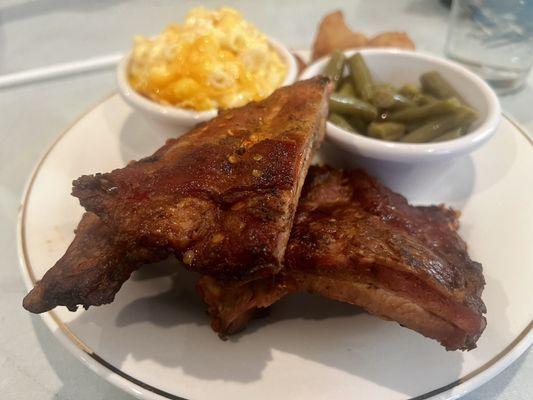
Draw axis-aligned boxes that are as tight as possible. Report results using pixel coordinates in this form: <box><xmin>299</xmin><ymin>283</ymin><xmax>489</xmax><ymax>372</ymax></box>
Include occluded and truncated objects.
<box><xmin>322</xmin><ymin>51</ymin><xmax>478</xmax><ymax>143</ymax></box>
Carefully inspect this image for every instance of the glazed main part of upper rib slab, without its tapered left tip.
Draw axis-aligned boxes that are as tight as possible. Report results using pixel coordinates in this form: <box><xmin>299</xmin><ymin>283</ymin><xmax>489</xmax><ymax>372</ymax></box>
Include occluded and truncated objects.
<box><xmin>73</xmin><ymin>77</ymin><xmax>331</xmax><ymax>279</ymax></box>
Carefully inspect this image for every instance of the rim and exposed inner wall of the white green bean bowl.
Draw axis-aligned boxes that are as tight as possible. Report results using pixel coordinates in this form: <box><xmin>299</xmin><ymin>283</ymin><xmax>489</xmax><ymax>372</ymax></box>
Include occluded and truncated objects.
<box><xmin>300</xmin><ymin>49</ymin><xmax>500</xmax><ymax>163</ymax></box>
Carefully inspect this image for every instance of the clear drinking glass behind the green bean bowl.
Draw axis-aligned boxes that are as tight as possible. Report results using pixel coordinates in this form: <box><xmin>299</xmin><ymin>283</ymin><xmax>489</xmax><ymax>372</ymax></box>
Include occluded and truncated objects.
<box><xmin>445</xmin><ymin>0</ymin><xmax>533</xmax><ymax>94</ymax></box>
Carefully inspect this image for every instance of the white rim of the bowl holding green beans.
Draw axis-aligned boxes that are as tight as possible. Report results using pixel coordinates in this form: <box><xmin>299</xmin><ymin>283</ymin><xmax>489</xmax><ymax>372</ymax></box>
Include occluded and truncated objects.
<box><xmin>300</xmin><ymin>48</ymin><xmax>501</xmax><ymax>161</ymax></box>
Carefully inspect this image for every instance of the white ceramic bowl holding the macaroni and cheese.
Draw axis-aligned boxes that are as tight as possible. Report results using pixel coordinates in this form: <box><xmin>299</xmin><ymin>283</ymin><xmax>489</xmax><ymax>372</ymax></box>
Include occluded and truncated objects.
<box><xmin>116</xmin><ymin>38</ymin><xmax>298</xmax><ymax>128</ymax></box>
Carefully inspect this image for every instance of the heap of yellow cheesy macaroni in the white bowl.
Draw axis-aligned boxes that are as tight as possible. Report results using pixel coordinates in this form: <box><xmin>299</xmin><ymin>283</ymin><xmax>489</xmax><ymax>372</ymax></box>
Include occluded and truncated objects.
<box><xmin>129</xmin><ymin>7</ymin><xmax>287</xmax><ymax>111</ymax></box>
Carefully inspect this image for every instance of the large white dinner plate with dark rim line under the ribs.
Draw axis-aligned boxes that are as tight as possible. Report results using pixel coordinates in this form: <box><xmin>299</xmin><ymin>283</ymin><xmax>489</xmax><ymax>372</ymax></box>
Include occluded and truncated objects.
<box><xmin>19</xmin><ymin>91</ymin><xmax>533</xmax><ymax>400</ymax></box>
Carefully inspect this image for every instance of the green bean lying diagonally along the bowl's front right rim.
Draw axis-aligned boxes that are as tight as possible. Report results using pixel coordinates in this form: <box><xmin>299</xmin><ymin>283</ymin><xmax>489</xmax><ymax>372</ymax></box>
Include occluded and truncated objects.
<box><xmin>401</xmin><ymin>107</ymin><xmax>477</xmax><ymax>143</ymax></box>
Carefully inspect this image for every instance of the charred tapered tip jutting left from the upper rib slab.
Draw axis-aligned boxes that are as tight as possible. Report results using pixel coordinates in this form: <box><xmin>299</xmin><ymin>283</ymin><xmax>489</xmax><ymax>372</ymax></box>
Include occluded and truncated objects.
<box><xmin>22</xmin><ymin>213</ymin><xmax>166</xmax><ymax>313</ymax></box>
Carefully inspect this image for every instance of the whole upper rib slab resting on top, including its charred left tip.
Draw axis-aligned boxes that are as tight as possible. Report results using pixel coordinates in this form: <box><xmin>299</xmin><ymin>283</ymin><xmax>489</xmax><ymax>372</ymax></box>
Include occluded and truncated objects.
<box><xmin>23</xmin><ymin>78</ymin><xmax>331</xmax><ymax>313</ymax></box>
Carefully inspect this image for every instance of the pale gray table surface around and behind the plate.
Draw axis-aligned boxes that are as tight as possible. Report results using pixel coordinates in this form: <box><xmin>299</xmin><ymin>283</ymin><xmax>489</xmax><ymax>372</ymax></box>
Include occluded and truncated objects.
<box><xmin>0</xmin><ymin>0</ymin><xmax>533</xmax><ymax>400</ymax></box>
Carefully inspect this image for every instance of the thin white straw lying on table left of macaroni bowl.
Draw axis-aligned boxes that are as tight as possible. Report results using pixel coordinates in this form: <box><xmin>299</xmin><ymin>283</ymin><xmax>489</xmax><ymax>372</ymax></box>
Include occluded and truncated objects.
<box><xmin>0</xmin><ymin>53</ymin><xmax>123</xmax><ymax>89</ymax></box>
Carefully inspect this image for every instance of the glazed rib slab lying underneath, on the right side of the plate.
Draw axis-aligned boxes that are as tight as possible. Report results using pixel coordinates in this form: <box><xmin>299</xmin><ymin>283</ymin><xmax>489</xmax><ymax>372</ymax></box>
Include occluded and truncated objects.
<box><xmin>198</xmin><ymin>167</ymin><xmax>485</xmax><ymax>350</ymax></box>
